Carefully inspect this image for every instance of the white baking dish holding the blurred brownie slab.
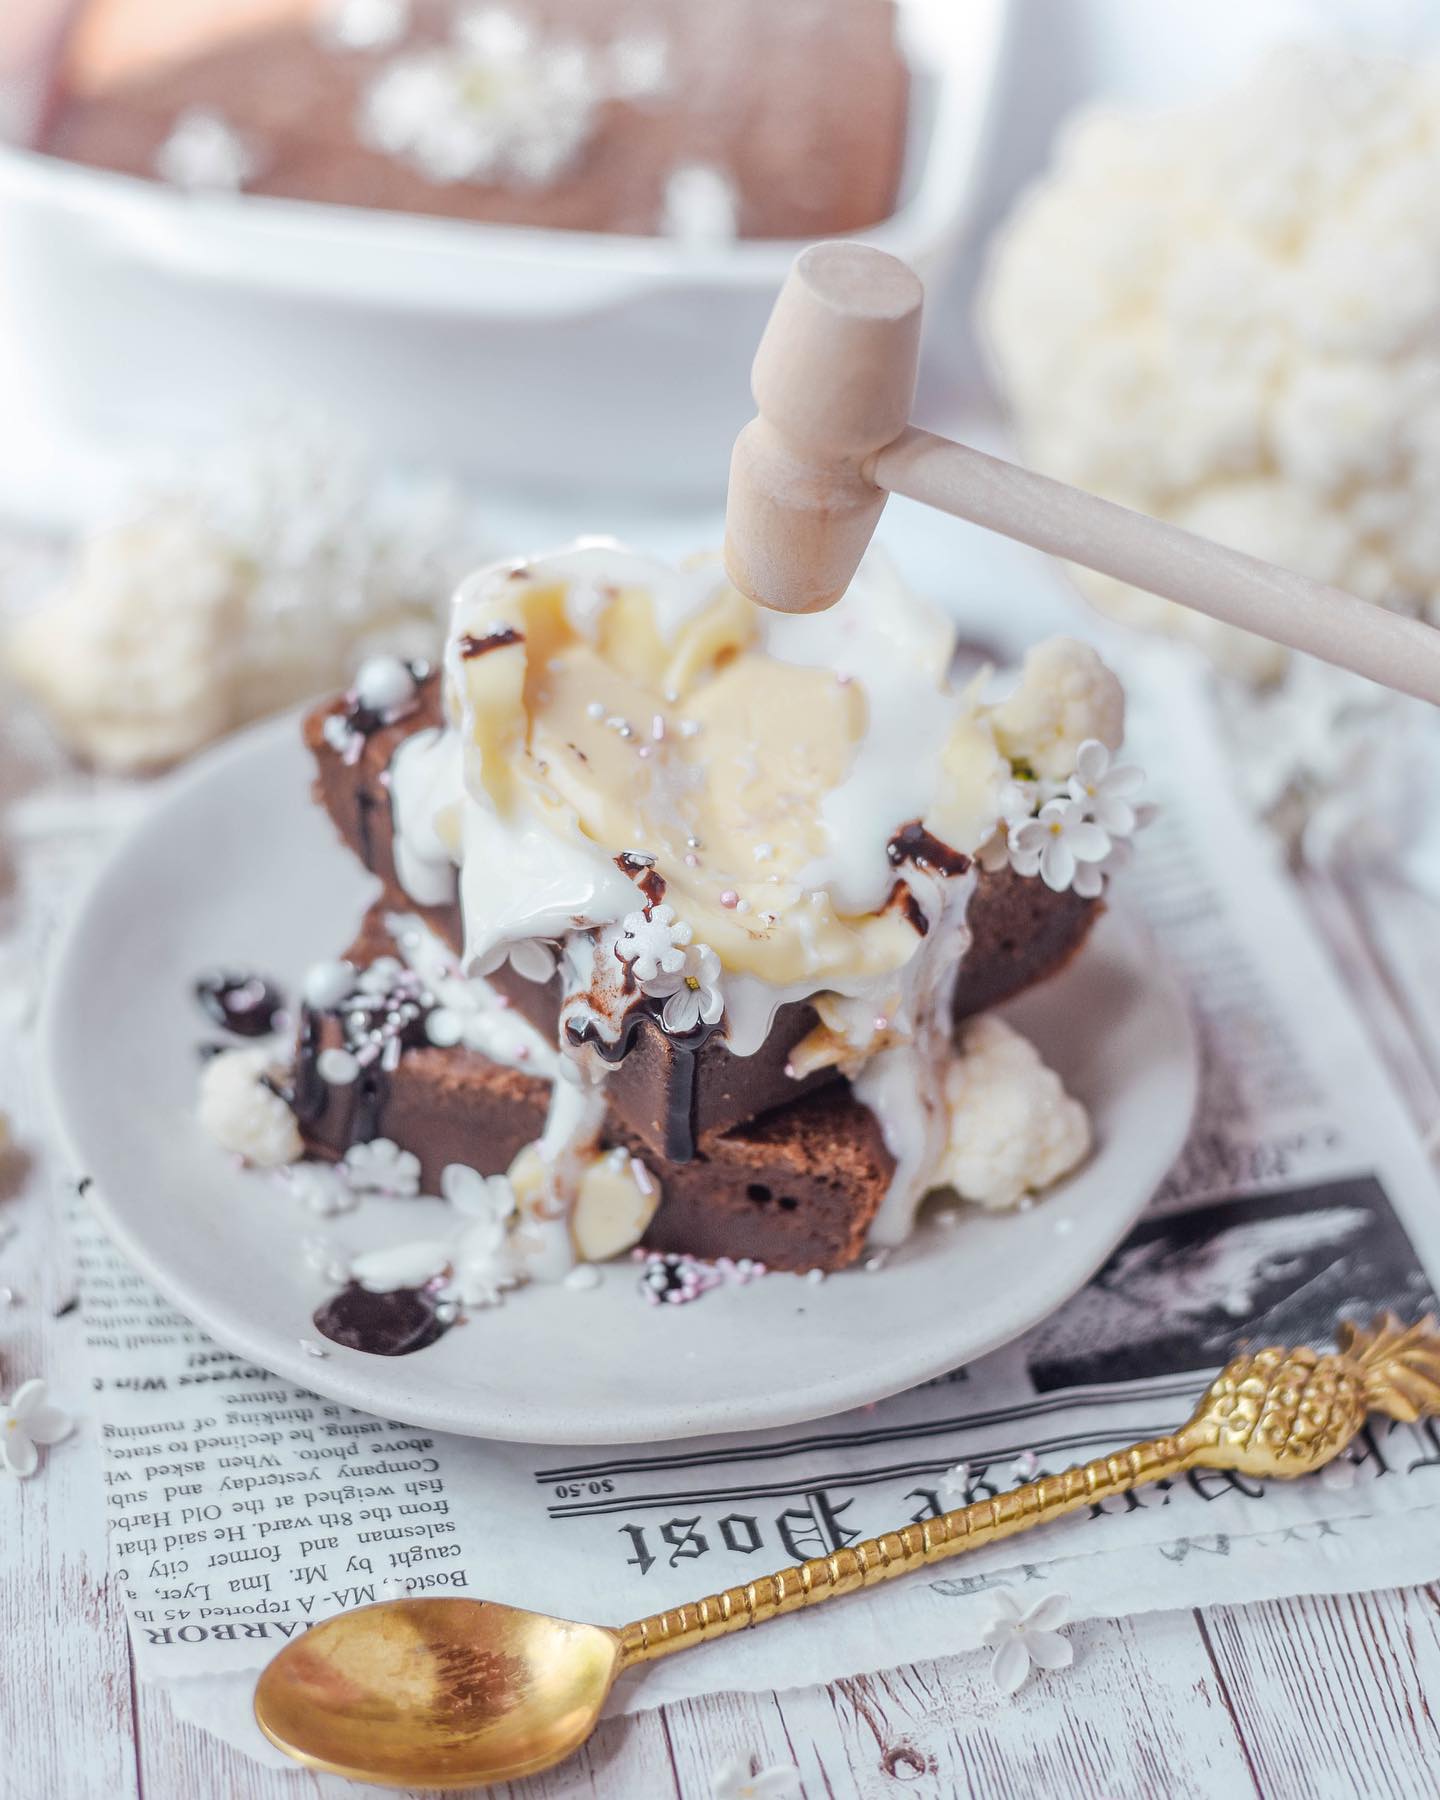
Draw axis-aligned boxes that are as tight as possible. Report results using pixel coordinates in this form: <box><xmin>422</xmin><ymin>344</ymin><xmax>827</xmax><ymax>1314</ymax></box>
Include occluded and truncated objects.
<box><xmin>0</xmin><ymin>0</ymin><xmax>1008</xmax><ymax>502</ymax></box>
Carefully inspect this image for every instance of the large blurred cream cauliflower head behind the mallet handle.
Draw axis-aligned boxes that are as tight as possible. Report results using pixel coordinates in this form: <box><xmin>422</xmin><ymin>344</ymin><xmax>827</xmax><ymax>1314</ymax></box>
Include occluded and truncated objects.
<box><xmin>979</xmin><ymin>49</ymin><xmax>1440</xmax><ymax>680</ymax></box>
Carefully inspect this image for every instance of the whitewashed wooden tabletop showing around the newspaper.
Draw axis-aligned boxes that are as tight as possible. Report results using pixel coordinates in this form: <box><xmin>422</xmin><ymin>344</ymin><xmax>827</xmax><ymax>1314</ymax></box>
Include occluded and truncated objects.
<box><xmin>0</xmin><ymin>554</ymin><xmax>1440</xmax><ymax>1800</ymax></box>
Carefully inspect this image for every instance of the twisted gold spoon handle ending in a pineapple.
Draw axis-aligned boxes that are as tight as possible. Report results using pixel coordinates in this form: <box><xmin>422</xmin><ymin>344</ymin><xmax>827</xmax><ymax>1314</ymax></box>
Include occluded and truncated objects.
<box><xmin>621</xmin><ymin>1314</ymin><xmax>1440</xmax><ymax>1667</ymax></box>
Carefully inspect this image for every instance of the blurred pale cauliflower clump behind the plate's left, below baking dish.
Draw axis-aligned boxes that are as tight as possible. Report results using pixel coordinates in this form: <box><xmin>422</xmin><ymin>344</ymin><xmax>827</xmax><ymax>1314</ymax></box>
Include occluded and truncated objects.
<box><xmin>0</xmin><ymin>418</ymin><xmax>473</xmax><ymax>772</ymax></box>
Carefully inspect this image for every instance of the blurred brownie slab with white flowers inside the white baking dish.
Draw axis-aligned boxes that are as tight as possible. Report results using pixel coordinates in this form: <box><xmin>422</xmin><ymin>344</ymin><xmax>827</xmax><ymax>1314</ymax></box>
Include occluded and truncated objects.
<box><xmin>38</xmin><ymin>0</ymin><xmax>909</xmax><ymax>238</ymax></box>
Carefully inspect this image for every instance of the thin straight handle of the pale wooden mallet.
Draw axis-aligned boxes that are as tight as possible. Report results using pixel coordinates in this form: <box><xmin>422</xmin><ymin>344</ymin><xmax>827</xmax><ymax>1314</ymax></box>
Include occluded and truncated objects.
<box><xmin>862</xmin><ymin>425</ymin><xmax>1440</xmax><ymax>702</ymax></box>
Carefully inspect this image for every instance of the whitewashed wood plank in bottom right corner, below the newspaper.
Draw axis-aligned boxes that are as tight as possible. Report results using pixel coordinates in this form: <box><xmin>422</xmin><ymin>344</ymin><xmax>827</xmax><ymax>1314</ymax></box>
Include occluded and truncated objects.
<box><xmin>1204</xmin><ymin>1588</ymin><xmax>1440</xmax><ymax>1800</ymax></box>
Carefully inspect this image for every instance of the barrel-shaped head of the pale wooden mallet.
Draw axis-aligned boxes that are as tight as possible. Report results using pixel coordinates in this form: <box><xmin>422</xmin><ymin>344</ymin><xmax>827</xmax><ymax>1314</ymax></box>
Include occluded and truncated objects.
<box><xmin>725</xmin><ymin>243</ymin><xmax>923</xmax><ymax>612</ymax></box>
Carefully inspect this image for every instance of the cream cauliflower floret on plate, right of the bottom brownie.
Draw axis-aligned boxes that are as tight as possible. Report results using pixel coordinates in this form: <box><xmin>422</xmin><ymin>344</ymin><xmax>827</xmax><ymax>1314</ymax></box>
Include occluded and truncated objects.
<box><xmin>940</xmin><ymin>1013</ymin><xmax>1091</xmax><ymax>1208</ymax></box>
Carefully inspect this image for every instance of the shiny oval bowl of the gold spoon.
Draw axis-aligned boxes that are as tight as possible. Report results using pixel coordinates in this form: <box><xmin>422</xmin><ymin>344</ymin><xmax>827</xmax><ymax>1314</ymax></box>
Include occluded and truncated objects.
<box><xmin>256</xmin><ymin>1598</ymin><xmax>621</xmax><ymax>1787</ymax></box>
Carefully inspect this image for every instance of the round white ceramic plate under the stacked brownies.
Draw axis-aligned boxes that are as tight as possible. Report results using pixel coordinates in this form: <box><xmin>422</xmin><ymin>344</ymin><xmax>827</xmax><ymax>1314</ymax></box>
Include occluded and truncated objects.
<box><xmin>45</xmin><ymin>718</ymin><xmax>1197</xmax><ymax>1444</ymax></box>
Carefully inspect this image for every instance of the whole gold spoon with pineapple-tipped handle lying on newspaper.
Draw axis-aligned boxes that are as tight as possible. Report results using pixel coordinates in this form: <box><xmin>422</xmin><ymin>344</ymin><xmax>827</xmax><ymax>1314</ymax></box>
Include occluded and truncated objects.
<box><xmin>256</xmin><ymin>1314</ymin><xmax>1440</xmax><ymax>1787</ymax></box>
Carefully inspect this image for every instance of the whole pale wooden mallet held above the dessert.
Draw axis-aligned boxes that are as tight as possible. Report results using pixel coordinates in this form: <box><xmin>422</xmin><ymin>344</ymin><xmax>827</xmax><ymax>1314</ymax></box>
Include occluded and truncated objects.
<box><xmin>725</xmin><ymin>243</ymin><xmax>1440</xmax><ymax>702</ymax></box>
